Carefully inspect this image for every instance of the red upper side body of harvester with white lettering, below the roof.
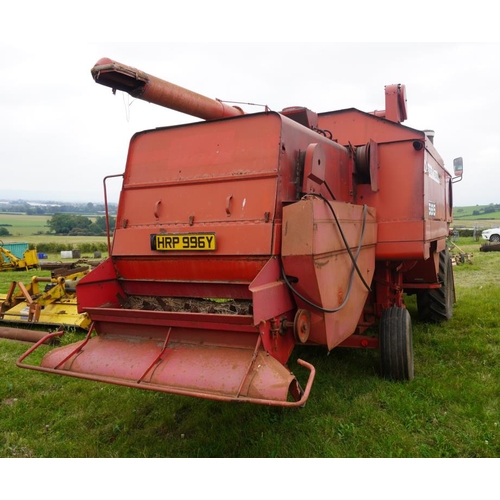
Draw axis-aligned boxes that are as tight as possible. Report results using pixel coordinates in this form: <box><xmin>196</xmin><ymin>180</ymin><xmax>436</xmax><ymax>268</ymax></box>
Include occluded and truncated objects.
<box><xmin>321</xmin><ymin>109</ymin><xmax>452</xmax><ymax>260</ymax></box>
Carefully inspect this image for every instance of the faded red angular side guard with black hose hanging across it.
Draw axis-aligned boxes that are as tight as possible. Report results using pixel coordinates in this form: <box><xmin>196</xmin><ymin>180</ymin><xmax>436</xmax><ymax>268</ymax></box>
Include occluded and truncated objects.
<box><xmin>282</xmin><ymin>198</ymin><xmax>376</xmax><ymax>349</ymax></box>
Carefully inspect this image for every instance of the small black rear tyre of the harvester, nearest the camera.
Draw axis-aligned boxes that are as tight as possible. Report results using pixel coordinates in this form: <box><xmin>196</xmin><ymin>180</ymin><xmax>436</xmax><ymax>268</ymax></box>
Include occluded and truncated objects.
<box><xmin>379</xmin><ymin>307</ymin><xmax>414</xmax><ymax>381</ymax></box>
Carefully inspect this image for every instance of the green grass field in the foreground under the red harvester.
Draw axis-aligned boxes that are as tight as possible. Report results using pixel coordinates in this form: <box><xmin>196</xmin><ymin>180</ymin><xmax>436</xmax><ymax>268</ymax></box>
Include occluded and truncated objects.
<box><xmin>0</xmin><ymin>236</ymin><xmax>500</xmax><ymax>458</ymax></box>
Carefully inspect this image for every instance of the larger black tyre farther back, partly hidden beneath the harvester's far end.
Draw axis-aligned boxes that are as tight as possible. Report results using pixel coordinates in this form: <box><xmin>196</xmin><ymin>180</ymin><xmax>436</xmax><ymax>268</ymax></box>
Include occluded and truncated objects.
<box><xmin>417</xmin><ymin>248</ymin><xmax>455</xmax><ymax>323</ymax></box>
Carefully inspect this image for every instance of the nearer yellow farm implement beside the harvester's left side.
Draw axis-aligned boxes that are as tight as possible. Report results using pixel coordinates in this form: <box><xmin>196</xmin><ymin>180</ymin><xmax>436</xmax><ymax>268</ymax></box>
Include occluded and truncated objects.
<box><xmin>0</xmin><ymin>267</ymin><xmax>90</xmax><ymax>330</ymax></box>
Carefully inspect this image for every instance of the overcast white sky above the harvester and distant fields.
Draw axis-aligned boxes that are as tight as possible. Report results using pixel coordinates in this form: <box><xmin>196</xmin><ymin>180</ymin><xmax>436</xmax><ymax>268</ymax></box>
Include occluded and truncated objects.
<box><xmin>0</xmin><ymin>6</ymin><xmax>500</xmax><ymax>206</ymax></box>
